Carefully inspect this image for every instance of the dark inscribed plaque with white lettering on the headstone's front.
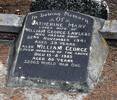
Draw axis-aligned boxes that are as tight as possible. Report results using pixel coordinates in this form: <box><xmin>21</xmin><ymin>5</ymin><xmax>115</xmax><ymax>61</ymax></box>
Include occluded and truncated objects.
<box><xmin>12</xmin><ymin>11</ymin><xmax>93</xmax><ymax>82</ymax></box>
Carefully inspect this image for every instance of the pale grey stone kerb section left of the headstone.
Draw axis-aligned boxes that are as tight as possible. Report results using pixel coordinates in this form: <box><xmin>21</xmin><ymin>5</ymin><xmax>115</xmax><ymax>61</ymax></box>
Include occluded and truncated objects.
<box><xmin>0</xmin><ymin>14</ymin><xmax>24</xmax><ymax>33</ymax></box>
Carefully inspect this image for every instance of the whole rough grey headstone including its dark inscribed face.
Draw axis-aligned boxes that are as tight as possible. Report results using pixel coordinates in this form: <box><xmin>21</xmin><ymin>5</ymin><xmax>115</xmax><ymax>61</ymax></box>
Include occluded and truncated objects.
<box><xmin>8</xmin><ymin>11</ymin><xmax>108</xmax><ymax>90</ymax></box>
